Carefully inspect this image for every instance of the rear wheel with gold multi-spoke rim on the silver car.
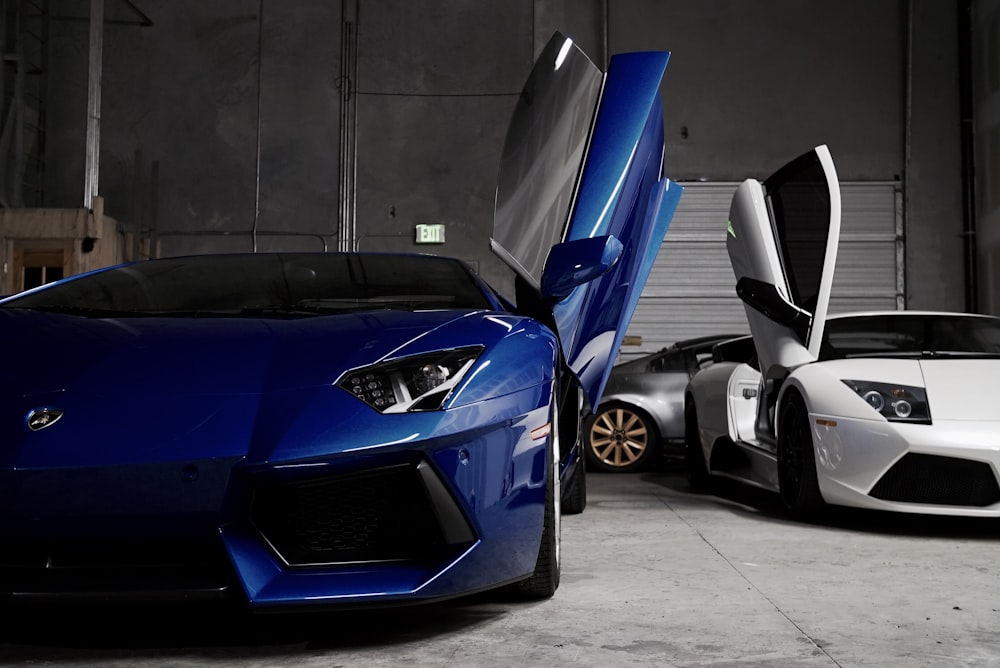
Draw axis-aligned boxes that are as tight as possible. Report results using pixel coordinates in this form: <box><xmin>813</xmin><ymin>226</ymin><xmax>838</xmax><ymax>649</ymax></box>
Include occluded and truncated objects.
<box><xmin>584</xmin><ymin>403</ymin><xmax>659</xmax><ymax>473</ymax></box>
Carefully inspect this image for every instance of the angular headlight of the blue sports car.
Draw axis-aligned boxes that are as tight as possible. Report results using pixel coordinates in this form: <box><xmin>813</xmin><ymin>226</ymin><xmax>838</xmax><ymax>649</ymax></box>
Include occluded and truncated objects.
<box><xmin>334</xmin><ymin>346</ymin><xmax>483</xmax><ymax>413</ymax></box>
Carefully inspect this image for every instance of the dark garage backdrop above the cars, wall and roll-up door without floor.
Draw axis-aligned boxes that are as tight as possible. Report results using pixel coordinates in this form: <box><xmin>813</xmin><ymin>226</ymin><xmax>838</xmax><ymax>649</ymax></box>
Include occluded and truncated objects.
<box><xmin>0</xmin><ymin>0</ymin><xmax>1000</xmax><ymax>326</ymax></box>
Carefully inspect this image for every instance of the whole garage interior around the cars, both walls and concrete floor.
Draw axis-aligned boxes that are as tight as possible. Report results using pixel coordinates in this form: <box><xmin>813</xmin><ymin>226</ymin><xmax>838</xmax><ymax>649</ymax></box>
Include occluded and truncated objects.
<box><xmin>0</xmin><ymin>0</ymin><xmax>1000</xmax><ymax>666</ymax></box>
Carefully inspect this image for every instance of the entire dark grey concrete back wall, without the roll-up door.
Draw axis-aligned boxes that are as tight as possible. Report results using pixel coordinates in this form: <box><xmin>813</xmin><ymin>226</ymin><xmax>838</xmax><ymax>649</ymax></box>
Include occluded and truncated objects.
<box><xmin>39</xmin><ymin>0</ymin><xmax>963</xmax><ymax>309</ymax></box>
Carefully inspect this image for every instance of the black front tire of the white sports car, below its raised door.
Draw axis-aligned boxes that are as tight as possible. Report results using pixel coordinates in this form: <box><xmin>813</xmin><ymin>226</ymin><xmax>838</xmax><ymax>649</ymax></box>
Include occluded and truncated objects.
<box><xmin>778</xmin><ymin>390</ymin><xmax>826</xmax><ymax>519</ymax></box>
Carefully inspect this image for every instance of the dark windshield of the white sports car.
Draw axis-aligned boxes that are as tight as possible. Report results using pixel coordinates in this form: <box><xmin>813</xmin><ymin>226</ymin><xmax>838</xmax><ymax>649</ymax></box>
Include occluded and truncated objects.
<box><xmin>820</xmin><ymin>313</ymin><xmax>1000</xmax><ymax>359</ymax></box>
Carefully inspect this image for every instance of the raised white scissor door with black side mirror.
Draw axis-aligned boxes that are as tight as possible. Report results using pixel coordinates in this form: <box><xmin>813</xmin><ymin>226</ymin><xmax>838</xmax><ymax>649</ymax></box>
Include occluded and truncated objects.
<box><xmin>726</xmin><ymin>146</ymin><xmax>840</xmax><ymax>436</ymax></box>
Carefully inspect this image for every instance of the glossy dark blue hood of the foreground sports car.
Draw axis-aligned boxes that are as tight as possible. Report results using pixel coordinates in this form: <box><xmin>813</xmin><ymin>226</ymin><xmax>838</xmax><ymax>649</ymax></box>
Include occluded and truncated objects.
<box><xmin>0</xmin><ymin>309</ymin><xmax>494</xmax><ymax>469</ymax></box>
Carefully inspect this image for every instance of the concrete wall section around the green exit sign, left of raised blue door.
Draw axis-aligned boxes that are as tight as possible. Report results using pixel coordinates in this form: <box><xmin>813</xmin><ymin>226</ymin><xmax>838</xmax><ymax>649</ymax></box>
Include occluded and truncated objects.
<box><xmin>356</xmin><ymin>0</ymin><xmax>534</xmax><ymax>288</ymax></box>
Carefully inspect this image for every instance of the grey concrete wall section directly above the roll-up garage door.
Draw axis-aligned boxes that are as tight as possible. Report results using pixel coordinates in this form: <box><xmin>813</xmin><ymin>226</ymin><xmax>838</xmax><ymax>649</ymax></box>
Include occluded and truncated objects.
<box><xmin>609</xmin><ymin>0</ymin><xmax>904</xmax><ymax>181</ymax></box>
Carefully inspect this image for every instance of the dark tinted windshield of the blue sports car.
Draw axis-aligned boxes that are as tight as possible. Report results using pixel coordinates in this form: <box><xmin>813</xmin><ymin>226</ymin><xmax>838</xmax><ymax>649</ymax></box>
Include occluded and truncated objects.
<box><xmin>0</xmin><ymin>253</ymin><xmax>492</xmax><ymax>315</ymax></box>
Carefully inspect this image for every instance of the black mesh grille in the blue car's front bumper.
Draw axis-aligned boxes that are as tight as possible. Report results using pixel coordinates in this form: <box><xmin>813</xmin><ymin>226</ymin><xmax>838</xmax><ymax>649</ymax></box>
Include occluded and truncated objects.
<box><xmin>251</xmin><ymin>466</ymin><xmax>444</xmax><ymax>565</ymax></box>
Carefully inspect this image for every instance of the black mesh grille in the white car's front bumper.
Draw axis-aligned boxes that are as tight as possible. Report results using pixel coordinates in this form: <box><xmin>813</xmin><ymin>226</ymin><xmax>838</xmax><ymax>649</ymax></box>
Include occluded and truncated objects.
<box><xmin>869</xmin><ymin>454</ymin><xmax>1000</xmax><ymax>507</ymax></box>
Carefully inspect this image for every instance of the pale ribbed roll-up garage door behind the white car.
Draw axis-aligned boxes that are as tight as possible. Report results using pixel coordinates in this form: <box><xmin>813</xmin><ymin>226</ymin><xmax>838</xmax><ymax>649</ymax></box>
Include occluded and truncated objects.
<box><xmin>619</xmin><ymin>182</ymin><xmax>904</xmax><ymax>360</ymax></box>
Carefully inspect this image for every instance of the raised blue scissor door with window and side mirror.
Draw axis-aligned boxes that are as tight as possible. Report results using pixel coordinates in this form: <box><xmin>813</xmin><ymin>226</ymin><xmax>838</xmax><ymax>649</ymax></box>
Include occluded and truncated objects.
<box><xmin>491</xmin><ymin>33</ymin><xmax>681</xmax><ymax>406</ymax></box>
